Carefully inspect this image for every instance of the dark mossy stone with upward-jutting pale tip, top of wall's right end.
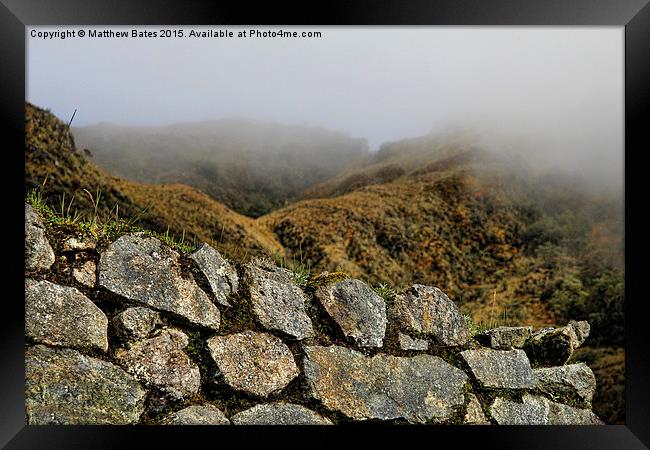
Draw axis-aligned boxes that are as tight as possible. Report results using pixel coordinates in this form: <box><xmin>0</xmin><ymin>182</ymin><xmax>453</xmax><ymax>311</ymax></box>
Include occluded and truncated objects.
<box><xmin>524</xmin><ymin>321</ymin><xmax>589</xmax><ymax>367</ymax></box>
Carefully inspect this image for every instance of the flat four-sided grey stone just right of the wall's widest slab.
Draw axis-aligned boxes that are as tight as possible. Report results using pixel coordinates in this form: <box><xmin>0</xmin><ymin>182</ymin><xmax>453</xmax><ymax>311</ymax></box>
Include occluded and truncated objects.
<box><xmin>460</xmin><ymin>348</ymin><xmax>534</xmax><ymax>389</ymax></box>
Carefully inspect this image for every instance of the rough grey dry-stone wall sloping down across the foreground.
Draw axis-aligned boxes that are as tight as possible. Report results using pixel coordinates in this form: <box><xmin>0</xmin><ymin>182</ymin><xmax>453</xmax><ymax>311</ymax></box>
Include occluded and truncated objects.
<box><xmin>25</xmin><ymin>205</ymin><xmax>602</xmax><ymax>425</ymax></box>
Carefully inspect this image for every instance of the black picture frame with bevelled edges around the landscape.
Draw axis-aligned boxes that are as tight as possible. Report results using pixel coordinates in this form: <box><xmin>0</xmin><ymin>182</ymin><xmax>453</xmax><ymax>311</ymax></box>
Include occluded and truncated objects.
<box><xmin>0</xmin><ymin>0</ymin><xmax>650</xmax><ymax>449</ymax></box>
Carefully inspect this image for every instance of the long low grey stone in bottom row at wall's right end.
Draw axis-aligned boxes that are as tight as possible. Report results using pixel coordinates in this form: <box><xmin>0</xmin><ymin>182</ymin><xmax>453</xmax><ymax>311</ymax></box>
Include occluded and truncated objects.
<box><xmin>490</xmin><ymin>394</ymin><xmax>602</xmax><ymax>425</ymax></box>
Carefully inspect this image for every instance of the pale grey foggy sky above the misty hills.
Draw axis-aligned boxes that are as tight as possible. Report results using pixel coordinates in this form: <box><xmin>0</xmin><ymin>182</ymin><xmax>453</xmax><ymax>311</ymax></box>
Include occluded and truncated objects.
<box><xmin>27</xmin><ymin>26</ymin><xmax>624</xmax><ymax>188</ymax></box>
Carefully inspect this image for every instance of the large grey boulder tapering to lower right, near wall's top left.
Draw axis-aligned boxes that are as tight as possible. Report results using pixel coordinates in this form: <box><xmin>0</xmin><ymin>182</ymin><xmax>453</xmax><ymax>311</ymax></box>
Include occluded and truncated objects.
<box><xmin>99</xmin><ymin>233</ymin><xmax>220</xmax><ymax>330</ymax></box>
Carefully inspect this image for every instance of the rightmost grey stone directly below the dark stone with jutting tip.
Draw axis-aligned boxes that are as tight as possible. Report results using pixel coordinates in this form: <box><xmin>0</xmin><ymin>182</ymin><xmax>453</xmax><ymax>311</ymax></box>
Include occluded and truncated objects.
<box><xmin>533</xmin><ymin>363</ymin><xmax>596</xmax><ymax>406</ymax></box>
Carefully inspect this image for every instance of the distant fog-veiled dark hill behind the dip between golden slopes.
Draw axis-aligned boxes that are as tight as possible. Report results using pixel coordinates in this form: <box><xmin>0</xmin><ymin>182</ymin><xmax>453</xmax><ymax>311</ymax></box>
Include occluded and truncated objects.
<box><xmin>72</xmin><ymin>119</ymin><xmax>368</xmax><ymax>217</ymax></box>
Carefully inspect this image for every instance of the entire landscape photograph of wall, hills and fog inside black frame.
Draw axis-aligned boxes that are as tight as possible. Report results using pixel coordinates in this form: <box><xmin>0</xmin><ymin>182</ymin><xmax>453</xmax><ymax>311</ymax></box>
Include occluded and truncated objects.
<box><xmin>24</xmin><ymin>25</ymin><xmax>626</xmax><ymax>426</ymax></box>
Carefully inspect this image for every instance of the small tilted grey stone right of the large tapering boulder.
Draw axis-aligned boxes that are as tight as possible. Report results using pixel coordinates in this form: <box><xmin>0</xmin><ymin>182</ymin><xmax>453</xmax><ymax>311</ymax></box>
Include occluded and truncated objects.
<box><xmin>190</xmin><ymin>244</ymin><xmax>239</xmax><ymax>306</ymax></box>
